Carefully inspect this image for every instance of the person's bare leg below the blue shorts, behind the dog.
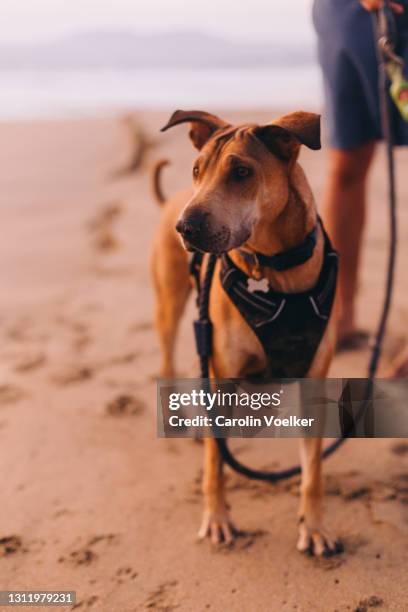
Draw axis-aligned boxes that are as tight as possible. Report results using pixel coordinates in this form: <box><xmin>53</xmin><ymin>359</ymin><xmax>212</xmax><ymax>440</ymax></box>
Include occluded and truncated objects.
<box><xmin>322</xmin><ymin>142</ymin><xmax>375</xmax><ymax>346</ymax></box>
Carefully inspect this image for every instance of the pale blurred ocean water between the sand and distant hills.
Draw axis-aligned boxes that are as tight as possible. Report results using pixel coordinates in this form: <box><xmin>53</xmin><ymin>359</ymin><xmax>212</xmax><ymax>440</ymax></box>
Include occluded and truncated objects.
<box><xmin>0</xmin><ymin>64</ymin><xmax>322</xmax><ymax>121</ymax></box>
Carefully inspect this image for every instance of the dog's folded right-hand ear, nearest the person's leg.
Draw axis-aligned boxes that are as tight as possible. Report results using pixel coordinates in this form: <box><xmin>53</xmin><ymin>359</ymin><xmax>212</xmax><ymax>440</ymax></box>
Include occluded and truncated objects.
<box><xmin>254</xmin><ymin>111</ymin><xmax>321</xmax><ymax>160</ymax></box>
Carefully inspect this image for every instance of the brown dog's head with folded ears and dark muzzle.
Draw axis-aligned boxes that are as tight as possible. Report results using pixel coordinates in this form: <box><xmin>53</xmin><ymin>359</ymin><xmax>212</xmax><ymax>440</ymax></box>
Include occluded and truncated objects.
<box><xmin>162</xmin><ymin>110</ymin><xmax>320</xmax><ymax>253</ymax></box>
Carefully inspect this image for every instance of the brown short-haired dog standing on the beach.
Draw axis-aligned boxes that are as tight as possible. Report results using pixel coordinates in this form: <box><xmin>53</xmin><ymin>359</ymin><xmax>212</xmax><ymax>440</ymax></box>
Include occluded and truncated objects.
<box><xmin>152</xmin><ymin>111</ymin><xmax>340</xmax><ymax>555</ymax></box>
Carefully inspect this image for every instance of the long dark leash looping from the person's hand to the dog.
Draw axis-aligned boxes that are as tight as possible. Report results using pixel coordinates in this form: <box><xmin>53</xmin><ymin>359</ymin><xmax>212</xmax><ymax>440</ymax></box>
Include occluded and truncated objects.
<box><xmin>194</xmin><ymin>0</ymin><xmax>397</xmax><ymax>482</ymax></box>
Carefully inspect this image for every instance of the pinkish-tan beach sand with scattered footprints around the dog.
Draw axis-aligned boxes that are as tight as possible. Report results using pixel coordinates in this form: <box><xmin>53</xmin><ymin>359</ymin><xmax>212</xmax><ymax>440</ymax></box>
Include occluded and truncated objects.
<box><xmin>0</xmin><ymin>112</ymin><xmax>408</xmax><ymax>612</ymax></box>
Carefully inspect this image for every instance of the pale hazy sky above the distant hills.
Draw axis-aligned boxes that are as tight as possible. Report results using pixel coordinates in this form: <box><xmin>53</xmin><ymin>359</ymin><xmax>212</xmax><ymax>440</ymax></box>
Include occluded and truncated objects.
<box><xmin>0</xmin><ymin>0</ymin><xmax>313</xmax><ymax>43</ymax></box>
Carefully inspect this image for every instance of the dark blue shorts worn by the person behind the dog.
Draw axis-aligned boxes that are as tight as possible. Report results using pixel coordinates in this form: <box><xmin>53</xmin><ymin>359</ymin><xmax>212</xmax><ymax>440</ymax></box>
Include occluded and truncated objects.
<box><xmin>313</xmin><ymin>0</ymin><xmax>408</xmax><ymax>149</ymax></box>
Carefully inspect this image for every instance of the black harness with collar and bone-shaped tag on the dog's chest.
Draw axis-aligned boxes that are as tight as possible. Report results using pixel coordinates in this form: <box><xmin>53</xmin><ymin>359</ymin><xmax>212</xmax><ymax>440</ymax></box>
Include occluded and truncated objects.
<box><xmin>191</xmin><ymin>220</ymin><xmax>338</xmax><ymax>378</ymax></box>
